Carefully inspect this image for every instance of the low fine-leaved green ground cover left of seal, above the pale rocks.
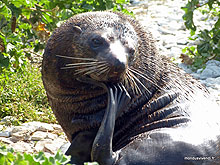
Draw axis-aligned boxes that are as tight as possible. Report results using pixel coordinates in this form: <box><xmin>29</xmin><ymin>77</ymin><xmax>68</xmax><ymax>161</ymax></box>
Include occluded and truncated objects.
<box><xmin>0</xmin><ymin>62</ymin><xmax>56</xmax><ymax>125</ymax></box>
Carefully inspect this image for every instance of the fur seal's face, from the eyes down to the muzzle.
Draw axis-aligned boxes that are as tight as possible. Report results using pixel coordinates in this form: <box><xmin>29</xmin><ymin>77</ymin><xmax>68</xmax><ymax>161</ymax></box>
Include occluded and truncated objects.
<box><xmin>84</xmin><ymin>28</ymin><xmax>135</xmax><ymax>82</ymax></box>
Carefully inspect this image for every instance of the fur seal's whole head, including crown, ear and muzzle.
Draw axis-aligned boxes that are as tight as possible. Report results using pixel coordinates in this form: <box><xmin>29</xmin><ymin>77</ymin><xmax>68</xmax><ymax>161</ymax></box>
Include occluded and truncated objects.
<box><xmin>47</xmin><ymin>12</ymin><xmax>138</xmax><ymax>83</ymax></box>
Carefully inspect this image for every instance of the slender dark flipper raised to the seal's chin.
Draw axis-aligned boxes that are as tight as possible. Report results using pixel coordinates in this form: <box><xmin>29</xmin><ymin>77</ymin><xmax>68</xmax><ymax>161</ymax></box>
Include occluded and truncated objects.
<box><xmin>91</xmin><ymin>84</ymin><xmax>130</xmax><ymax>165</ymax></box>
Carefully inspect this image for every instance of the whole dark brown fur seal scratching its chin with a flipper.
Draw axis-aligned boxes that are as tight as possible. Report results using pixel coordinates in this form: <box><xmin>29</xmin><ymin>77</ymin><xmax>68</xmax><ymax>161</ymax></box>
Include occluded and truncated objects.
<box><xmin>42</xmin><ymin>12</ymin><xmax>220</xmax><ymax>165</ymax></box>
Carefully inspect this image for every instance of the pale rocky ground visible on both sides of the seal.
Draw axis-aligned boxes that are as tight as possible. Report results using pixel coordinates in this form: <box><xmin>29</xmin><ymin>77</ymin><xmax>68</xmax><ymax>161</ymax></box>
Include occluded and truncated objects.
<box><xmin>0</xmin><ymin>0</ymin><xmax>220</xmax><ymax>155</ymax></box>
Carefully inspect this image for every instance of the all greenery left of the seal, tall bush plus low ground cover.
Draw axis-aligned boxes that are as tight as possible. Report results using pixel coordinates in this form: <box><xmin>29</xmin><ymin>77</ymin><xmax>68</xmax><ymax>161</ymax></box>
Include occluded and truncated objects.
<box><xmin>0</xmin><ymin>0</ymin><xmax>128</xmax><ymax>125</ymax></box>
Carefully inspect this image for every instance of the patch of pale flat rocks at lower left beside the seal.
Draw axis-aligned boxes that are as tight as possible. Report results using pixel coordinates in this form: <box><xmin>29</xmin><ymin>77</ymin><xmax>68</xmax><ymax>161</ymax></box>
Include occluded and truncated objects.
<box><xmin>0</xmin><ymin>120</ymin><xmax>68</xmax><ymax>156</ymax></box>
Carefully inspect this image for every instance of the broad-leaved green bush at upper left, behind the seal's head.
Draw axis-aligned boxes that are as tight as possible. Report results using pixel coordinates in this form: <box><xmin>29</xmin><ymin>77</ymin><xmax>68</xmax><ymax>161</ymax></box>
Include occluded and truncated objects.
<box><xmin>0</xmin><ymin>0</ymin><xmax>131</xmax><ymax>73</ymax></box>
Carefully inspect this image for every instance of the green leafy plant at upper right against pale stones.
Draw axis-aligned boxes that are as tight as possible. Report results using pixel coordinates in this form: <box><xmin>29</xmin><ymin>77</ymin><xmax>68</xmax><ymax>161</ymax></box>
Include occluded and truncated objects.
<box><xmin>182</xmin><ymin>0</ymin><xmax>220</xmax><ymax>68</ymax></box>
